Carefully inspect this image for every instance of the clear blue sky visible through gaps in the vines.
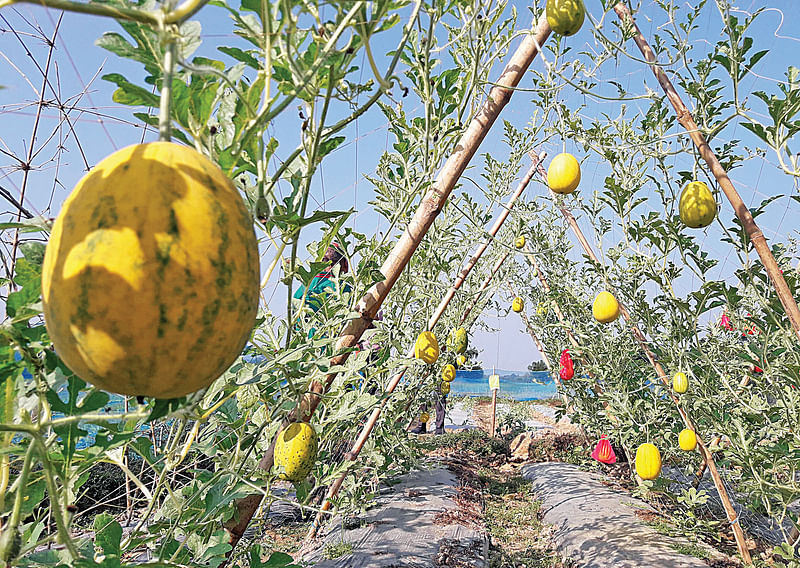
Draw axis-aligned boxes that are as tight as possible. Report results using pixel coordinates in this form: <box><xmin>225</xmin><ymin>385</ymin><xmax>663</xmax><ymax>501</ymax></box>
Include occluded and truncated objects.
<box><xmin>0</xmin><ymin>0</ymin><xmax>800</xmax><ymax>369</ymax></box>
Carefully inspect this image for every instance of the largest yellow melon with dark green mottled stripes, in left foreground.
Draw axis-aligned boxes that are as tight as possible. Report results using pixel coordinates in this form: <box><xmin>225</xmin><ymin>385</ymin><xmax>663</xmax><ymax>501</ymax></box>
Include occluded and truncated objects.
<box><xmin>42</xmin><ymin>142</ymin><xmax>259</xmax><ymax>398</ymax></box>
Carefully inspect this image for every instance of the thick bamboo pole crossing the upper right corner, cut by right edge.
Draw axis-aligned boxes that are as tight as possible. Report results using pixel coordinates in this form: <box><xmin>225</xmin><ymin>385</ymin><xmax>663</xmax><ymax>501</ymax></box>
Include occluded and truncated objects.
<box><xmin>614</xmin><ymin>2</ymin><xmax>800</xmax><ymax>339</ymax></box>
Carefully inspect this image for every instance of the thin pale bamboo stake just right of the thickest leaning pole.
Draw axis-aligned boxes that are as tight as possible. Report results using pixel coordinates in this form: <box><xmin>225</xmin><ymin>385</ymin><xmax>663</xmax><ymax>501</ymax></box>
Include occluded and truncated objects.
<box><xmin>306</xmin><ymin>152</ymin><xmax>547</xmax><ymax>539</ymax></box>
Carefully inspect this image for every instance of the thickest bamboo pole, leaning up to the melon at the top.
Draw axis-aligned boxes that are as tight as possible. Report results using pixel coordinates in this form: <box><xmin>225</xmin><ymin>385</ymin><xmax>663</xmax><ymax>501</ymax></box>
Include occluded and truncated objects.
<box><xmin>225</xmin><ymin>13</ymin><xmax>550</xmax><ymax>557</ymax></box>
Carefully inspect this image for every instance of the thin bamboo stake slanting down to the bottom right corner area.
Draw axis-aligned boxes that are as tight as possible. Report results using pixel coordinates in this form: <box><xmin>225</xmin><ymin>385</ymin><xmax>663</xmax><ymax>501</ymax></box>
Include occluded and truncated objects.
<box><xmin>550</xmin><ymin>191</ymin><xmax>752</xmax><ymax>564</ymax></box>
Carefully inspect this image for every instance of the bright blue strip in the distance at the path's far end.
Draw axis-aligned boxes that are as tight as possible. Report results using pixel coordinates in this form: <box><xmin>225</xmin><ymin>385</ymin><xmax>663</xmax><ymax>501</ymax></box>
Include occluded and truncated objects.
<box><xmin>450</xmin><ymin>369</ymin><xmax>558</xmax><ymax>400</ymax></box>
